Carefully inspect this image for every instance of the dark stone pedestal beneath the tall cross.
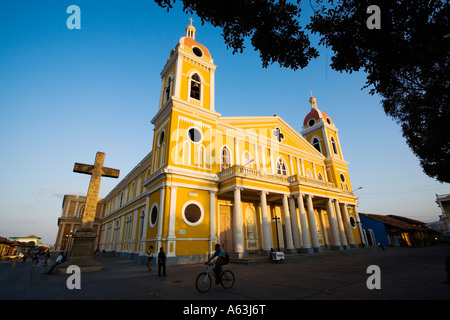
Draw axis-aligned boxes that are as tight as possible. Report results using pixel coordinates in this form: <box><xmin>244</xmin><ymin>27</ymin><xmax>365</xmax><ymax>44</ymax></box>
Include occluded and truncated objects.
<box><xmin>55</xmin><ymin>229</ymin><xmax>102</xmax><ymax>274</ymax></box>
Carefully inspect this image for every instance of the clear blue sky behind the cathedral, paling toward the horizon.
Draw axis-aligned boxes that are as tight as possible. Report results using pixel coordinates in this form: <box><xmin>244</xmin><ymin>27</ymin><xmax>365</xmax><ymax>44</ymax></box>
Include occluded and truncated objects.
<box><xmin>0</xmin><ymin>0</ymin><xmax>450</xmax><ymax>244</ymax></box>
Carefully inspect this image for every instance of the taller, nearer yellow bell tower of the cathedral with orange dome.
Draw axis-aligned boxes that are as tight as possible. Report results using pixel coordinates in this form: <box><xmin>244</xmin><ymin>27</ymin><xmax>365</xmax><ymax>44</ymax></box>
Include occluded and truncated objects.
<box><xmin>151</xmin><ymin>19</ymin><xmax>220</xmax><ymax>178</ymax></box>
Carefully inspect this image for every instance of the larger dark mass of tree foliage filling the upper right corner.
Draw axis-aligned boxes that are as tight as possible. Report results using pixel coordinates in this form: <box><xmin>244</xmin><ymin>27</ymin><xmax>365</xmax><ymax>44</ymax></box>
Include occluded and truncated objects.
<box><xmin>308</xmin><ymin>0</ymin><xmax>450</xmax><ymax>182</ymax></box>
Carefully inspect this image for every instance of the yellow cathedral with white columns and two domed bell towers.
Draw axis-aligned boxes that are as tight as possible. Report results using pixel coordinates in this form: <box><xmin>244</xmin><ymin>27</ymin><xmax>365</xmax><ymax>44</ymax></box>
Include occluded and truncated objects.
<box><xmin>55</xmin><ymin>22</ymin><xmax>361</xmax><ymax>265</ymax></box>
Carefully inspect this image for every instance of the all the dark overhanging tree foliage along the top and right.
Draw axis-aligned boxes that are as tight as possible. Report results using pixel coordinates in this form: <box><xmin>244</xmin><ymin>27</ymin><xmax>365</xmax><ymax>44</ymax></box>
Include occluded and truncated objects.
<box><xmin>155</xmin><ymin>0</ymin><xmax>450</xmax><ymax>182</ymax></box>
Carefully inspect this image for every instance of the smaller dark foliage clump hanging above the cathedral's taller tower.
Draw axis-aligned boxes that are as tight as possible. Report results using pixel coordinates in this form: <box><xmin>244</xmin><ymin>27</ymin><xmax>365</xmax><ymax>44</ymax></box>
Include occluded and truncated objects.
<box><xmin>155</xmin><ymin>0</ymin><xmax>318</xmax><ymax>70</ymax></box>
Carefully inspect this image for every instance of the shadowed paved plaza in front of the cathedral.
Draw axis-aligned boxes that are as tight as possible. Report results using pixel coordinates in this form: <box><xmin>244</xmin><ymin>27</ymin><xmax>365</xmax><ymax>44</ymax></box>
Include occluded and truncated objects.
<box><xmin>0</xmin><ymin>246</ymin><xmax>450</xmax><ymax>305</ymax></box>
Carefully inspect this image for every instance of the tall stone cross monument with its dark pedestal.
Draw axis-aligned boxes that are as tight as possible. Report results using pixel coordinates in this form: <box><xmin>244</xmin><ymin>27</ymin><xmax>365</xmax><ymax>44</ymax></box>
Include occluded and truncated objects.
<box><xmin>56</xmin><ymin>152</ymin><xmax>120</xmax><ymax>274</ymax></box>
